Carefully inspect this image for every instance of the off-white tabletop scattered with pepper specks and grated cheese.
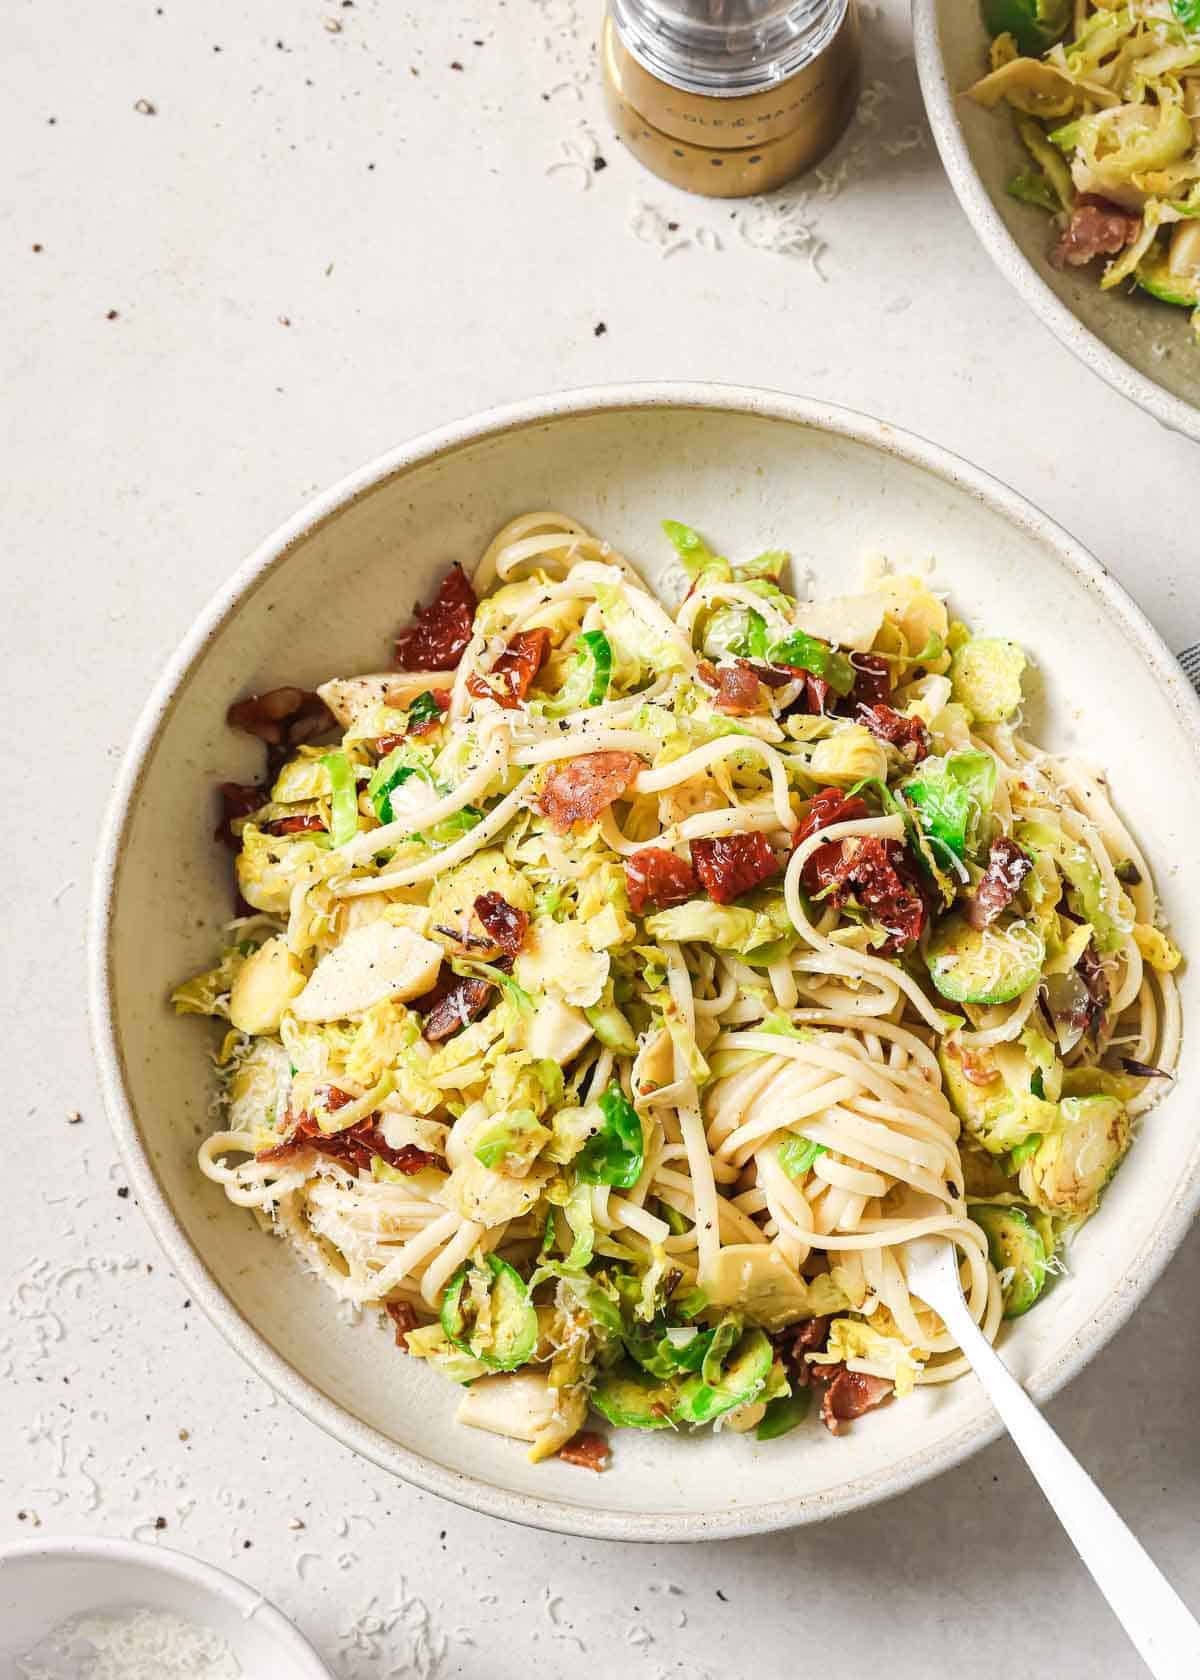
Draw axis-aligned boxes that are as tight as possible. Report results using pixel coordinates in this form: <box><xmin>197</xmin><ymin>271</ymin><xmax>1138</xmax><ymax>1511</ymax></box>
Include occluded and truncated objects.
<box><xmin>0</xmin><ymin>0</ymin><xmax>1200</xmax><ymax>1680</ymax></box>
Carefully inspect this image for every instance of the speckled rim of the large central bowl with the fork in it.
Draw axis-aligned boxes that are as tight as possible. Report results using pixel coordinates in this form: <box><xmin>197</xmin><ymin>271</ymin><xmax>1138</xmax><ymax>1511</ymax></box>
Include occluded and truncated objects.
<box><xmin>87</xmin><ymin>381</ymin><xmax>1200</xmax><ymax>1541</ymax></box>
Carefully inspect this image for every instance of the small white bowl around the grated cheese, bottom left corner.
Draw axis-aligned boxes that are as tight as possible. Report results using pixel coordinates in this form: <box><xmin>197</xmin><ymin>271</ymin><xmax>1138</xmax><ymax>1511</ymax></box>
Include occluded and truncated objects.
<box><xmin>0</xmin><ymin>1539</ymin><xmax>331</xmax><ymax>1680</ymax></box>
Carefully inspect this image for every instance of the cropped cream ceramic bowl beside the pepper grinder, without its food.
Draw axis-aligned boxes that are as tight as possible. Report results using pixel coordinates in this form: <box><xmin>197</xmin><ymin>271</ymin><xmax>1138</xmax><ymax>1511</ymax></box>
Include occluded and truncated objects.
<box><xmin>913</xmin><ymin>0</ymin><xmax>1200</xmax><ymax>442</ymax></box>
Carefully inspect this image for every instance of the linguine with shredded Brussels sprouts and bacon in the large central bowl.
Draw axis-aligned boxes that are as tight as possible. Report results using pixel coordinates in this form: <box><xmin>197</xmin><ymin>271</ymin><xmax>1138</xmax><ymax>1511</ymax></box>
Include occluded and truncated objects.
<box><xmin>173</xmin><ymin>512</ymin><xmax>1180</xmax><ymax>1468</ymax></box>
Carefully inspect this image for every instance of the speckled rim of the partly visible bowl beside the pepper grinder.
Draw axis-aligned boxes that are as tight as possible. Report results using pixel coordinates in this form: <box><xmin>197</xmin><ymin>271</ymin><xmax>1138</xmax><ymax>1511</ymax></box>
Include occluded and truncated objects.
<box><xmin>913</xmin><ymin>0</ymin><xmax>1200</xmax><ymax>444</ymax></box>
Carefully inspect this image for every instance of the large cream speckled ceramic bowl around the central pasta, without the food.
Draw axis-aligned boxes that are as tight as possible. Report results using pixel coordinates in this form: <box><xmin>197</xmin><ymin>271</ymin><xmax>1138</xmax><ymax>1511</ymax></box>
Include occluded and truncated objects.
<box><xmin>91</xmin><ymin>385</ymin><xmax>1200</xmax><ymax>1539</ymax></box>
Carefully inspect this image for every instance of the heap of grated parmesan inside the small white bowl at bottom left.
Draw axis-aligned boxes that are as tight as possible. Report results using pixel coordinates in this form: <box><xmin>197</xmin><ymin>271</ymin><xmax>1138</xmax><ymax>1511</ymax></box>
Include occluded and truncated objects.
<box><xmin>17</xmin><ymin>1609</ymin><xmax>242</xmax><ymax>1680</ymax></box>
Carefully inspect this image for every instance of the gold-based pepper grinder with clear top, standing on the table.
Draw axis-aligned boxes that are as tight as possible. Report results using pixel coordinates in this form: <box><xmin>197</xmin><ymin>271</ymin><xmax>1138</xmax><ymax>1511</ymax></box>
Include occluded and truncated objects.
<box><xmin>602</xmin><ymin>0</ymin><xmax>862</xmax><ymax>198</ymax></box>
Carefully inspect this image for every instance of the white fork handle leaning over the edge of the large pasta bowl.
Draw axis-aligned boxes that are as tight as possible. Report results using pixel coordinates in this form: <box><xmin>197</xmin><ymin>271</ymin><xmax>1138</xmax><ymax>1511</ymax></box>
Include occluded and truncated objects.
<box><xmin>938</xmin><ymin>1299</ymin><xmax>1200</xmax><ymax>1680</ymax></box>
